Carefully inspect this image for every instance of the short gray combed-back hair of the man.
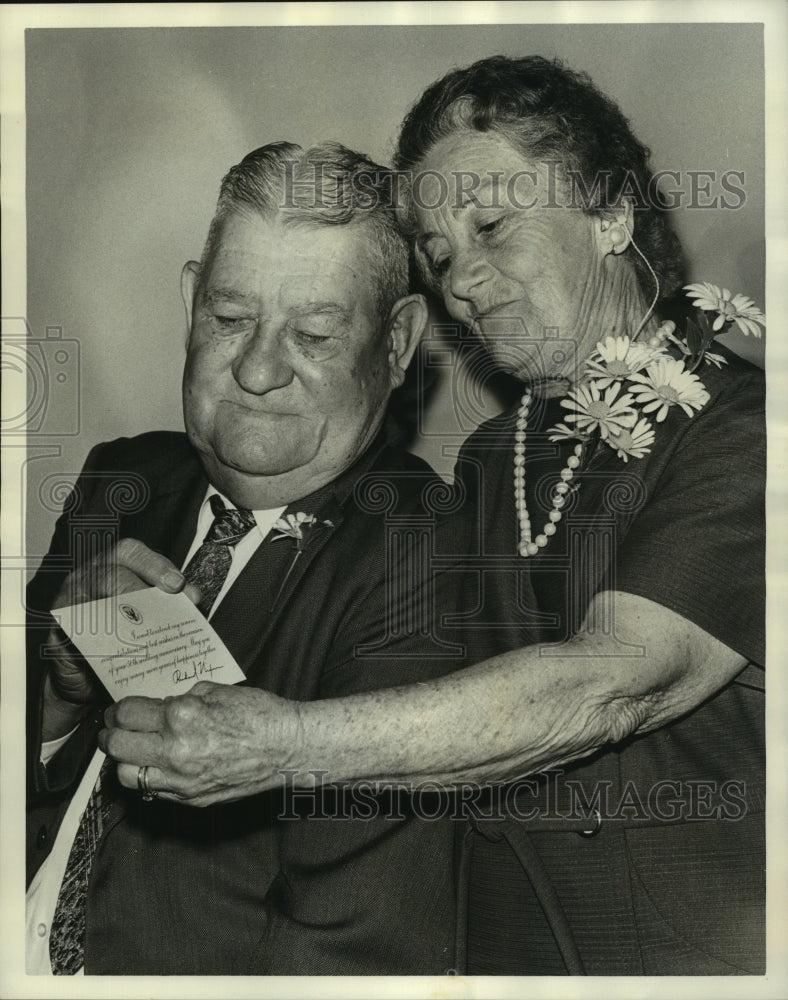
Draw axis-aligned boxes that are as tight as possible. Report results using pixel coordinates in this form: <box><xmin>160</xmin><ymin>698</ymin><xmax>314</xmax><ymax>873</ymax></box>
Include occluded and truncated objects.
<box><xmin>200</xmin><ymin>142</ymin><xmax>408</xmax><ymax>323</ymax></box>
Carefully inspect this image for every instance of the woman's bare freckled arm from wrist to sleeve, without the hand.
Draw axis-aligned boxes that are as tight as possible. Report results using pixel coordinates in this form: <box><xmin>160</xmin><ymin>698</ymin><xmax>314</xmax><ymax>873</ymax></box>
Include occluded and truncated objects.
<box><xmin>290</xmin><ymin>593</ymin><xmax>746</xmax><ymax>783</ymax></box>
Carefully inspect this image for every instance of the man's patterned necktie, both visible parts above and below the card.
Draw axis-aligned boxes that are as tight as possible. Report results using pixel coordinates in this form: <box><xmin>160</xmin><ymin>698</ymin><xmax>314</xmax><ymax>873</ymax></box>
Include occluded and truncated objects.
<box><xmin>49</xmin><ymin>494</ymin><xmax>256</xmax><ymax>976</ymax></box>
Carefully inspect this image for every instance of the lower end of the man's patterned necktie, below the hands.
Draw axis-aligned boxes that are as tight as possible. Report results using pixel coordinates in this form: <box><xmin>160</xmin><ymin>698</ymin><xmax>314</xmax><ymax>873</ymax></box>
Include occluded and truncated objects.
<box><xmin>49</xmin><ymin>757</ymin><xmax>112</xmax><ymax>976</ymax></box>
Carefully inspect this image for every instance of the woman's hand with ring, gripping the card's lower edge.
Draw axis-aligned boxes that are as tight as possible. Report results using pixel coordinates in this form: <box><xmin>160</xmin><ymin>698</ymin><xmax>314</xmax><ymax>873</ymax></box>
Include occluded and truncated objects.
<box><xmin>99</xmin><ymin>681</ymin><xmax>301</xmax><ymax>806</ymax></box>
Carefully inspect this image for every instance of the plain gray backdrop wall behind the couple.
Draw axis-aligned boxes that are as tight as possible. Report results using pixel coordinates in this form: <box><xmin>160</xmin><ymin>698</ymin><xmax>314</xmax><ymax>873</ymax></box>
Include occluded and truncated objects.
<box><xmin>26</xmin><ymin>24</ymin><xmax>764</xmax><ymax>568</ymax></box>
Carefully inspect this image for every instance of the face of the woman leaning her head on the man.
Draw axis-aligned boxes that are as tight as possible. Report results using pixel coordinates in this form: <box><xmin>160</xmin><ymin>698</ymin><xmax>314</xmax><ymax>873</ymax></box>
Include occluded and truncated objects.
<box><xmin>413</xmin><ymin>131</ymin><xmax>609</xmax><ymax>380</ymax></box>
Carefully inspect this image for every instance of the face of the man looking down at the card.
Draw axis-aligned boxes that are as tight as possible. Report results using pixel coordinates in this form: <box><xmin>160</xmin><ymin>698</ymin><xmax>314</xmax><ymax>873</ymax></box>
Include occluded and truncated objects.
<box><xmin>183</xmin><ymin>213</ymin><xmax>397</xmax><ymax>508</ymax></box>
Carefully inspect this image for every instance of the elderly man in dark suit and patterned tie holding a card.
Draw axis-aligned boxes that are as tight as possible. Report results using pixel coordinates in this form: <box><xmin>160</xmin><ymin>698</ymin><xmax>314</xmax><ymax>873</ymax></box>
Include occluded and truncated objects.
<box><xmin>28</xmin><ymin>137</ymin><xmax>459</xmax><ymax>974</ymax></box>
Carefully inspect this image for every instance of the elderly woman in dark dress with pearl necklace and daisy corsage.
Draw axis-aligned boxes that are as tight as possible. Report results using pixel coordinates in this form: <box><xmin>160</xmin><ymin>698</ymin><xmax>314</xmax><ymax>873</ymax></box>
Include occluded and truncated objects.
<box><xmin>101</xmin><ymin>57</ymin><xmax>764</xmax><ymax>974</ymax></box>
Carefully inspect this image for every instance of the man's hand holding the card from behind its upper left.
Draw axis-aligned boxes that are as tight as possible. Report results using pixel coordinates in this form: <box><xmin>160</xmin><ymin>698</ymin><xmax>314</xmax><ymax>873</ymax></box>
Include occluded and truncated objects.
<box><xmin>43</xmin><ymin>538</ymin><xmax>199</xmax><ymax>741</ymax></box>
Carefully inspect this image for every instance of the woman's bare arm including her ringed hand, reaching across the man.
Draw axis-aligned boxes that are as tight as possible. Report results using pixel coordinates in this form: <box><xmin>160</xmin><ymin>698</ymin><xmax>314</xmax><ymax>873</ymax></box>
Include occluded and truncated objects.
<box><xmin>100</xmin><ymin>593</ymin><xmax>745</xmax><ymax>805</ymax></box>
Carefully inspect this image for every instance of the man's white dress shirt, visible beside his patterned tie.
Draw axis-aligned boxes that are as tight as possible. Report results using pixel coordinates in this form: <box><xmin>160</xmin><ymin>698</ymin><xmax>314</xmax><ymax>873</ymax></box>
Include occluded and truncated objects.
<box><xmin>25</xmin><ymin>487</ymin><xmax>285</xmax><ymax>976</ymax></box>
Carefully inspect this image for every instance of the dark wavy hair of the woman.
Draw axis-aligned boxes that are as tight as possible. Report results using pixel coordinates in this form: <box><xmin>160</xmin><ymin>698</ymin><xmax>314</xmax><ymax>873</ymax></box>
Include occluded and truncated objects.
<box><xmin>395</xmin><ymin>56</ymin><xmax>682</xmax><ymax>299</ymax></box>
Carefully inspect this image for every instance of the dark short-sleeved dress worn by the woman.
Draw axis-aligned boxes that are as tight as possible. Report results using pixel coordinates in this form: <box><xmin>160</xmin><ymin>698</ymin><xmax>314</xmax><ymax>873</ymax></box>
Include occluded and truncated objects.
<box><xmin>457</xmin><ymin>354</ymin><xmax>765</xmax><ymax>975</ymax></box>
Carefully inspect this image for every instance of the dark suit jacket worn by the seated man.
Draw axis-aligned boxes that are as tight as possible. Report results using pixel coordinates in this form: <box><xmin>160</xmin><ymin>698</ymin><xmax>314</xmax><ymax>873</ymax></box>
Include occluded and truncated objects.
<box><xmin>28</xmin><ymin>432</ymin><xmax>468</xmax><ymax>975</ymax></box>
